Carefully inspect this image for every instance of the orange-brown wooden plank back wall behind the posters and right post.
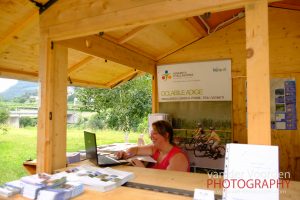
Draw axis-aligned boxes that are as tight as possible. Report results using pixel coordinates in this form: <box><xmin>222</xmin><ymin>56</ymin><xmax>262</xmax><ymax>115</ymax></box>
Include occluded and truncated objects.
<box><xmin>159</xmin><ymin>8</ymin><xmax>300</xmax><ymax>180</ymax></box>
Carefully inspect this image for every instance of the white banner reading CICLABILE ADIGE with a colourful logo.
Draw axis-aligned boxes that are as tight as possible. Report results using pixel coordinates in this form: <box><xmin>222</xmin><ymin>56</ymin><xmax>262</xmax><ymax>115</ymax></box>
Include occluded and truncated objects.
<box><xmin>157</xmin><ymin>60</ymin><xmax>232</xmax><ymax>102</ymax></box>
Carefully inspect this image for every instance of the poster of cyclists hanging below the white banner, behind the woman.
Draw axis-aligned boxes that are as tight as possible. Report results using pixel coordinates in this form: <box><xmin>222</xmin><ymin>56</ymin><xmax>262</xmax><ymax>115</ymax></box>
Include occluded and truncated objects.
<box><xmin>159</xmin><ymin>101</ymin><xmax>232</xmax><ymax>172</ymax></box>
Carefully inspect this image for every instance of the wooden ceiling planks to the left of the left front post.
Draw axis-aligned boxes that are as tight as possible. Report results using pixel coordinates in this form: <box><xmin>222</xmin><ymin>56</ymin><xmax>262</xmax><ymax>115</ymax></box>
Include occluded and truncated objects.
<box><xmin>0</xmin><ymin>0</ymin><xmax>39</xmax><ymax>80</ymax></box>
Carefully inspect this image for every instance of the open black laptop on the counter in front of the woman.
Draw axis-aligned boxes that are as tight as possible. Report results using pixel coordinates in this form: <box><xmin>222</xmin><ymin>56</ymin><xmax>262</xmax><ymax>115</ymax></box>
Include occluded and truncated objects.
<box><xmin>84</xmin><ymin>131</ymin><xmax>128</xmax><ymax>167</ymax></box>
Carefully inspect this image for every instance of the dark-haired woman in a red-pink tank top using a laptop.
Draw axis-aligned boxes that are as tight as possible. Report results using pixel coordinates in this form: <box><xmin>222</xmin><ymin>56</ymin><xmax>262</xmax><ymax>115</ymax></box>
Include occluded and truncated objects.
<box><xmin>117</xmin><ymin>120</ymin><xmax>190</xmax><ymax>171</ymax></box>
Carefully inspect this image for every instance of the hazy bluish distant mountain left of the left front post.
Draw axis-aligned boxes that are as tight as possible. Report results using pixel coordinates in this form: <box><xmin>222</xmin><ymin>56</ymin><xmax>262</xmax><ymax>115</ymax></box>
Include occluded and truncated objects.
<box><xmin>0</xmin><ymin>81</ymin><xmax>38</xmax><ymax>100</ymax></box>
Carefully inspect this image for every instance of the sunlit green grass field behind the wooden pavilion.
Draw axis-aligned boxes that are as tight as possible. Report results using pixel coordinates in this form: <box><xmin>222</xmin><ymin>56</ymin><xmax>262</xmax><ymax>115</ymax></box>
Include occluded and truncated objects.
<box><xmin>0</xmin><ymin>128</ymin><xmax>150</xmax><ymax>184</ymax></box>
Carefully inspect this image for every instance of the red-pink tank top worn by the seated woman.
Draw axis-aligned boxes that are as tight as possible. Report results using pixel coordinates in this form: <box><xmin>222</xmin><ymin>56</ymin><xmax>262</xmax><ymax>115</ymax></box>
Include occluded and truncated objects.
<box><xmin>150</xmin><ymin>146</ymin><xmax>190</xmax><ymax>172</ymax></box>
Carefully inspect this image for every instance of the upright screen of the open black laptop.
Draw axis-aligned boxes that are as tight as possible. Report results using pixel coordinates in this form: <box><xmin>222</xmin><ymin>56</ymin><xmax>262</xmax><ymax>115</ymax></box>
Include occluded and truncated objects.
<box><xmin>84</xmin><ymin>131</ymin><xmax>98</xmax><ymax>165</ymax></box>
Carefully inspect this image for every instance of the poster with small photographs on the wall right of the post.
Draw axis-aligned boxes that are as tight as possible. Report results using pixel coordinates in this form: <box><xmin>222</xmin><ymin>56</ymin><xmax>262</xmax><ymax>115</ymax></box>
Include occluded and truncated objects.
<box><xmin>271</xmin><ymin>78</ymin><xmax>297</xmax><ymax>130</ymax></box>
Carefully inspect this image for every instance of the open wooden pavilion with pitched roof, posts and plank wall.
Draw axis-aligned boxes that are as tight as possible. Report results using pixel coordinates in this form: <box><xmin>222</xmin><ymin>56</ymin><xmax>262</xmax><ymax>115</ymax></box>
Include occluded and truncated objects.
<box><xmin>0</xmin><ymin>0</ymin><xmax>300</xmax><ymax>180</ymax></box>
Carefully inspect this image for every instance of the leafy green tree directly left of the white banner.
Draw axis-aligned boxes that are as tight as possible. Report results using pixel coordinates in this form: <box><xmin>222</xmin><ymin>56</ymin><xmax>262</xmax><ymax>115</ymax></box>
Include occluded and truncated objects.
<box><xmin>75</xmin><ymin>75</ymin><xmax>152</xmax><ymax>131</ymax></box>
